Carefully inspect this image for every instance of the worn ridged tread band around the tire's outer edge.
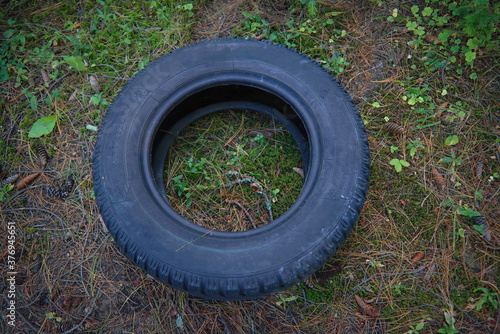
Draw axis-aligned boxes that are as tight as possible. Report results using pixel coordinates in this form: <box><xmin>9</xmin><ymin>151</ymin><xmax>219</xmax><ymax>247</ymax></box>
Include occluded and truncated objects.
<box><xmin>93</xmin><ymin>37</ymin><xmax>370</xmax><ymax>300</ymax></box>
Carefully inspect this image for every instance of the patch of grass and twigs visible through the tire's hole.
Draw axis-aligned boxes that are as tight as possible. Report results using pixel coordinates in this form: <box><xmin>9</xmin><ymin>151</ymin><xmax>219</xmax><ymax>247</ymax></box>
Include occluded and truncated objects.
<box><xmin>163</xmin><ymin>109</ymin><xmax>303</xmax><ymax>232</ymax></box>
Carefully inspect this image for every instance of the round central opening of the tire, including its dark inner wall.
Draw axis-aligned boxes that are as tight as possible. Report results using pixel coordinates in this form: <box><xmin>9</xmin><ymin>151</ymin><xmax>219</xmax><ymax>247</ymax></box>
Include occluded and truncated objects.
<box><xmin>152</xmin><ymin>84</ymin><xmax>310</xmax><ymax>232</ymax></box>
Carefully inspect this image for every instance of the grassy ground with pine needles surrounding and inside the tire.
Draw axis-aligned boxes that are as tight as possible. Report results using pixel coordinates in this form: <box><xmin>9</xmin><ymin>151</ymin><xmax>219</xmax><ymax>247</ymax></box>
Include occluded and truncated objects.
<box><xmin>0</xmin><ymin>0</ymin><xmax>500</xmax><ymax>333</ymax></box>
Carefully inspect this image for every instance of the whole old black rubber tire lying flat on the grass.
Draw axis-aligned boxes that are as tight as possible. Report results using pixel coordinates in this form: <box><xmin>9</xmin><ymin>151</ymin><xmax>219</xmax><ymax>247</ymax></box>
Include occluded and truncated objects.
<box><xmin>93</xmin><ymin>39</ymin><xmax>370</xmax><ymax>300</ymax></box>
